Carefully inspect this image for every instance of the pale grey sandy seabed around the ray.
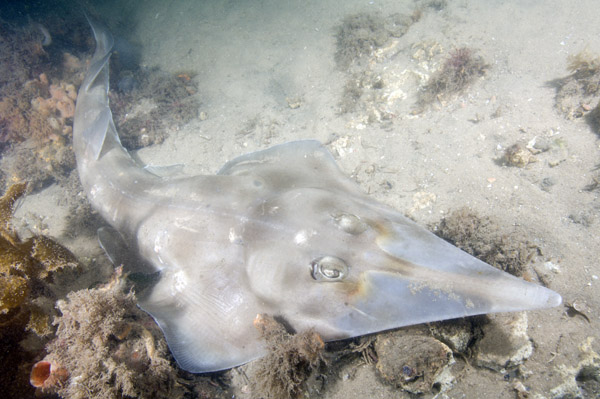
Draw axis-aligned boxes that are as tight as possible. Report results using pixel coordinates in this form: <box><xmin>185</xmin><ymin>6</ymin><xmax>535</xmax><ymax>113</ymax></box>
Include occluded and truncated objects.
<box><xmin>7</xmin><ymin>0</ymin><xmax>600</xmax><ymax>399</ymax></box>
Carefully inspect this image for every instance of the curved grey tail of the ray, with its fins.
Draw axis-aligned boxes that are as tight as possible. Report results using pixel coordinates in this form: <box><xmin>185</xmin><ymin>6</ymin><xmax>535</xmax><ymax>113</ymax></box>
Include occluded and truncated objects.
<box><xmin>73</xmin><ymin>17</ymin><xmax>157</xmax><ymax>238</ymax></box>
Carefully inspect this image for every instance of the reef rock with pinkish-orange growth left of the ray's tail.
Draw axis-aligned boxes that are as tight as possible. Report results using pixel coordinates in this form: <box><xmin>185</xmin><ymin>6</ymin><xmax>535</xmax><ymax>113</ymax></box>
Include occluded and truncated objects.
<box><xmin>0</xmin><ymin>13</ymin><xmax>88</xmax><ymax>187</ymax></box>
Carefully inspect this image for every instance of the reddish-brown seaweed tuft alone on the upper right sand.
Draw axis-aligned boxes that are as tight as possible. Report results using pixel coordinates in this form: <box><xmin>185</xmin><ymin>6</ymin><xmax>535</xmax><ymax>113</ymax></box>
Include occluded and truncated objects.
<box><xmin>419</xmin><ymin>47</ymin><xmax>489</xmax><ymax>105</ymax></box>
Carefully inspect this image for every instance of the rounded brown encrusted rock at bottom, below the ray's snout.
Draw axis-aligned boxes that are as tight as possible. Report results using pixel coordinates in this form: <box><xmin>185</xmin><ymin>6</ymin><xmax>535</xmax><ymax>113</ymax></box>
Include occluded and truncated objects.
<box><xmin>375</xmin><ymin>328</ymin><xmax>454</xmax><ymax>394</ymax></box>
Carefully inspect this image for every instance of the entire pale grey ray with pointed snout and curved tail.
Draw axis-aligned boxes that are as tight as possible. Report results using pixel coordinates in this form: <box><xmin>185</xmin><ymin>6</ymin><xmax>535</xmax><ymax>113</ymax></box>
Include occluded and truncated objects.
<box><xmin>74</xmin><ymin>22</ymin><xmax>561</xmax><ymax>372</ymax></box>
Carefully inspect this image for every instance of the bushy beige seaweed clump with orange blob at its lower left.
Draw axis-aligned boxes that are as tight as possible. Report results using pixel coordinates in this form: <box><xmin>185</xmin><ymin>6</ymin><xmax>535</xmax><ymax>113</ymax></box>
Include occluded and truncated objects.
<box><xmin>32</xmin><ymin>269</ymin><xmax>181</xmax><ymax>399</ymax></box>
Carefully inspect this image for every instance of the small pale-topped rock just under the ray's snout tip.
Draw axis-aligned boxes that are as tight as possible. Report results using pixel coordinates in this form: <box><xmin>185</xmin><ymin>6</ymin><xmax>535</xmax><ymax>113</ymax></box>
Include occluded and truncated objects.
<box><xmin>476</xmin><ymin>312</ymin><xmax>533</xmax><ymax>372</ymax></box>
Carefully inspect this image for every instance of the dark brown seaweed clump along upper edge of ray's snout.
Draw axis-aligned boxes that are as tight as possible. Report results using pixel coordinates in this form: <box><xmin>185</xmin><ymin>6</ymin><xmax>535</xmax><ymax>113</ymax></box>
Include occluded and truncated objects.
<box><xmin>434</xmin><ymin>208</ymin><xmax>540</xmax><ymax>277</ymax></box>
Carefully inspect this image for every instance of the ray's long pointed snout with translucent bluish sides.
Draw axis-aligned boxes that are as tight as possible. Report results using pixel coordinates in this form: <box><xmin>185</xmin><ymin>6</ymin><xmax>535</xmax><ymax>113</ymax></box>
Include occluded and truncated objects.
<box><xmin>338</xmin><ymin>220</ymin><xmax>562</xmax><ymax>335</ymax></box>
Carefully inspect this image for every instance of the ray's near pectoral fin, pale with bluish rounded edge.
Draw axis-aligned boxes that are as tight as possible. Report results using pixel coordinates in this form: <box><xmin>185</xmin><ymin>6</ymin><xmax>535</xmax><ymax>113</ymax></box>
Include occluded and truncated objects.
<box><xmin>138</xmin><ymin>265</ymin><xmax>265</xmax><ymax>373</ymax></box>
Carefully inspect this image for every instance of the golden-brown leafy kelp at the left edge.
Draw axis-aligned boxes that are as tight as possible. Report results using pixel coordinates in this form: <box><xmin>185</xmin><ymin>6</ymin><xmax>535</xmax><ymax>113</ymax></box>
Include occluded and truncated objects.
<box><xmin>0</xmin><ymin>183</ymin><xmax>78</xmax><ymax>397</ymax></box>
